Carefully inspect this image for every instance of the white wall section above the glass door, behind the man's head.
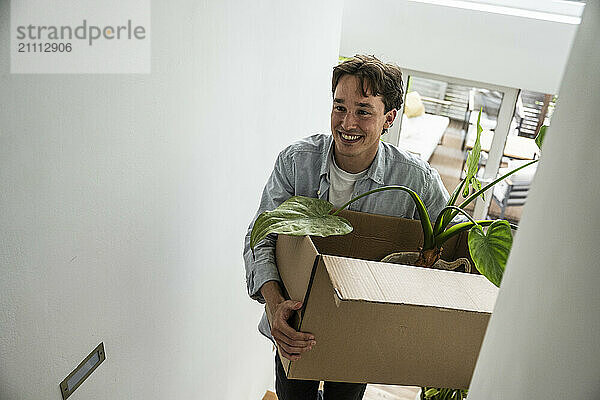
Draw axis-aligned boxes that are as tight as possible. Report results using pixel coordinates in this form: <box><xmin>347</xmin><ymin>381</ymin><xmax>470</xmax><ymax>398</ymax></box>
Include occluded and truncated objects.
<box><xmin>340</xmin><ymin>0</ymin><xmax>578</xmax><ymax>93</ymax></box>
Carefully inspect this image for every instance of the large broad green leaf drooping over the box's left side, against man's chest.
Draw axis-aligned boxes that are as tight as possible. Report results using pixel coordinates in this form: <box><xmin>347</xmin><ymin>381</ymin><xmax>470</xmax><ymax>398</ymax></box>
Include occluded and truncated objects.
<box><xmin>250</xmin><ymin>196</ymin><xmax>352</xmax><ymax>251</ymax></box>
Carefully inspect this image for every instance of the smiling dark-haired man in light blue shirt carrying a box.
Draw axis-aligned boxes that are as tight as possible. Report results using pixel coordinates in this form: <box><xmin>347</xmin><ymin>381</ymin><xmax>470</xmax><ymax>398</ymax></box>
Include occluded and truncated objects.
<box><xmin>244</xmin><ymin>55</ymin><xmax>449</xmax><ymax>400</ymax></box>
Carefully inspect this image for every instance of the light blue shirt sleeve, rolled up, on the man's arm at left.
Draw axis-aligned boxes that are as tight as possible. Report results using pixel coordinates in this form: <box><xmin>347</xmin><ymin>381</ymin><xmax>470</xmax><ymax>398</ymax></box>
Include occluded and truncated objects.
<box><xmin>244</xmin><ymin>150</ymin><xmax>295</xmax><ymax>303</ymax></box>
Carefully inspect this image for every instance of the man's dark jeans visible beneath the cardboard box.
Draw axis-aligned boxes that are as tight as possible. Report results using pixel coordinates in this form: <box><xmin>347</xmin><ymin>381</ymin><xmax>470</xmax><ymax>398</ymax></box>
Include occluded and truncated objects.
<box><xmin>275</xmin><ymin>353</ymin><xmax>367</xmax><ymax>400</ymax></box>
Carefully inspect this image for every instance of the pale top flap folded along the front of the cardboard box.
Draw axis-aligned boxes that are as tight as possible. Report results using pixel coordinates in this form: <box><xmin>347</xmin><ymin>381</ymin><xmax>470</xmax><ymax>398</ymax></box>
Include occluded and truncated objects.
<box><xmin>323</xmin><ymin>255</ymin><xmax>498</xmax><ymax>313</ymax></box>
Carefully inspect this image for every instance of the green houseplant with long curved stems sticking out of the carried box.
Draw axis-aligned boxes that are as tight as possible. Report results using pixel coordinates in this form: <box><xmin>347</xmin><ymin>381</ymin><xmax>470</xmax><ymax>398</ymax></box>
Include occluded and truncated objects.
<box><xmin>250</xmin><ymin>111</ymin><xmax>539</xmax><ymax>286</ymax></box>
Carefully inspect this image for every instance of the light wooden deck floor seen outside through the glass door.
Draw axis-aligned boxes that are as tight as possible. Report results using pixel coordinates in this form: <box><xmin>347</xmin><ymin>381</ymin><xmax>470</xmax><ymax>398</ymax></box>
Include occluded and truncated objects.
<box><xmin>429</xmin><ymin>120</ymin><xmax>523</xmax><ymax>223</ymax></box>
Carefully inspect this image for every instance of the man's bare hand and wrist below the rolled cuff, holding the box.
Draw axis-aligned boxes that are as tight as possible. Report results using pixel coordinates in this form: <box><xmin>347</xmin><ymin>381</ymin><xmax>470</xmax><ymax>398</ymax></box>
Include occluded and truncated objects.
<box><xmin>260</xmin><ymin>281</ymin><xmax>317</xmax><ymax>361</ymax></box>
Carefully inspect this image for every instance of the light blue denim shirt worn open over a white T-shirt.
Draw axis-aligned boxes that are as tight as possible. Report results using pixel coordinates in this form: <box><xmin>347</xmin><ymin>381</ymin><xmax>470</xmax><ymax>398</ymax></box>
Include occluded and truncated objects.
<box><xmin>244</xmin><ymin>134</ymin><xmax>449</xmax><ymax>340</ymax></box>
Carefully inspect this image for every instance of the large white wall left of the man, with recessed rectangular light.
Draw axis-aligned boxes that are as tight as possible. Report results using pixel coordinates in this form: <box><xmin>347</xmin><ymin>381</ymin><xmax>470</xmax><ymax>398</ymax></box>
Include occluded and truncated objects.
<box><xmin>0</xmin><ymin>0</ymin><xmax>342</xmax><ymax>400</ymax></box>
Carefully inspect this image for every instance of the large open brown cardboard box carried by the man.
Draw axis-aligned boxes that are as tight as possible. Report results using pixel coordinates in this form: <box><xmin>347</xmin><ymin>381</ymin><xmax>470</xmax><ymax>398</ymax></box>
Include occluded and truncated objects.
<box><xmin>267</xmin><ymin>211</ymin><xmax>498</xmax><ymax>388</ymax></box>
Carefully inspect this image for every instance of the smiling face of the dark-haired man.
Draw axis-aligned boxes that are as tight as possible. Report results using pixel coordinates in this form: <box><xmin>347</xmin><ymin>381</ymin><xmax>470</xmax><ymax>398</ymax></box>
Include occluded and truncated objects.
<box><xmin>331</xmin><ymin>75</ymin><xmax>396</xmax><ymax>173</ymax></box>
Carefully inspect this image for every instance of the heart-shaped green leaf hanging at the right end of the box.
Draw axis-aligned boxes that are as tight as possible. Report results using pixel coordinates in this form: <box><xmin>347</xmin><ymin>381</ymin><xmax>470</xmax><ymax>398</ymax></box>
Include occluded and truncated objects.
<box><xmin>468</xmin><ymin>220</ymin><xmax>512</xmax><ymax>287</ymax></box>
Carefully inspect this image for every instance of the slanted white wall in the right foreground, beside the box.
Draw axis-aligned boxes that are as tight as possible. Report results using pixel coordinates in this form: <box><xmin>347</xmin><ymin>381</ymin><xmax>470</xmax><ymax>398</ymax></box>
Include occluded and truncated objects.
<box><xmin>469</xmin><ymin>1</ymin><xmax>600</xmax><ymax>400</ymax></box>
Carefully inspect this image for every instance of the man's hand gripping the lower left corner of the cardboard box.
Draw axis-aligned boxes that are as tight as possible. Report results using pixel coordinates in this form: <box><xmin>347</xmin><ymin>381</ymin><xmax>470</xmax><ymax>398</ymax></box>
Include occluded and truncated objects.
<box><xmin>271</xmin><ymin>300</ymin><xmax>317</xmax><ymax>361</ymax></box>
